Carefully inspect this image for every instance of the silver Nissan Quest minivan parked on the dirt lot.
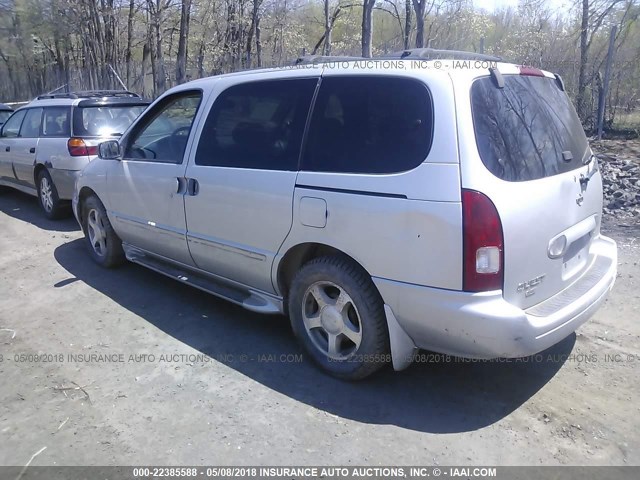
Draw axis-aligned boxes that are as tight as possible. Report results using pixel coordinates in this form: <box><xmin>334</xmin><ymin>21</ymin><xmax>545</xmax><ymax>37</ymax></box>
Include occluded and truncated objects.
<box><xmin>73</xmin><ymin>50</ymin><xmax>617</xmax><ymax>379</ymax></box>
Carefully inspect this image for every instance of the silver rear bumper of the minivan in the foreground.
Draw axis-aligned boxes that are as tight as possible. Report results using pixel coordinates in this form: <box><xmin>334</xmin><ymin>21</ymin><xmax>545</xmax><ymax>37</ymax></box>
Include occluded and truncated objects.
<box><xmin>373</xmin><ymin>236</ymin><xmax>617</xmax><ymax>359</ymax></box>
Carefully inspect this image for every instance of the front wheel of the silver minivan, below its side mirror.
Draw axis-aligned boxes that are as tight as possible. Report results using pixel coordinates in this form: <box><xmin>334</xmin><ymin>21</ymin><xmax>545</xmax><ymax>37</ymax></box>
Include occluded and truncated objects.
<box><xmin>81</xmin><ymin>195</ymin><xmax>126</xmax><ymax>268</ymax></box>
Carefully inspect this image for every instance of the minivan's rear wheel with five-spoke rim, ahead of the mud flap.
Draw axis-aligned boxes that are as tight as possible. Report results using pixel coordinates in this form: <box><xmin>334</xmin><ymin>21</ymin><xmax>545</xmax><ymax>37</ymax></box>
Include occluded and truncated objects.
<box><xmin>289</xmin><ymin>256</ymin><xmax>391</xmax><ymax>380</ymax></box>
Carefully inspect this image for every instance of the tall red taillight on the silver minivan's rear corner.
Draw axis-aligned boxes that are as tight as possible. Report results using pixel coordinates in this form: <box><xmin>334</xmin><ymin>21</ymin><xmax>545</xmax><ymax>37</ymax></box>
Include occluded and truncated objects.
<box><xmin>462</xmin><ymin>189</ymin><xmax>504</xmax><ymax>292</ymax></box>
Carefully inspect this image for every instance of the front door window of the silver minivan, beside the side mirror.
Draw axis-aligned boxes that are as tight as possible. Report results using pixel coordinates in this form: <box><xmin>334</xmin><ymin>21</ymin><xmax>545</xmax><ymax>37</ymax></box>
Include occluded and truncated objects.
<box><xmin>124</xmin><ymin>91</ymin><xmax>202</xmax><ymax>163</ymax></box>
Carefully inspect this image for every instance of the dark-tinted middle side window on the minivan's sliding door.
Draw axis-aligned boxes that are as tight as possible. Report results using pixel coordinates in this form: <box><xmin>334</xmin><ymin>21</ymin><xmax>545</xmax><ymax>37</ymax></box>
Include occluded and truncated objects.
<box><xmin>196</xmin><ymin>78</ymin><xmax>318</xmax><ymax>170</ymax></box>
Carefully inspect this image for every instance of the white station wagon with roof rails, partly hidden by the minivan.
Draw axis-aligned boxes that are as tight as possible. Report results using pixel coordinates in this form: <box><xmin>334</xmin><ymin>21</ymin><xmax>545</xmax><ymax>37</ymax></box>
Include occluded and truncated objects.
<box><xmin>0</xmin><ymin>90</ymin><xmax>151</xmax><ymax>219</ymax></box>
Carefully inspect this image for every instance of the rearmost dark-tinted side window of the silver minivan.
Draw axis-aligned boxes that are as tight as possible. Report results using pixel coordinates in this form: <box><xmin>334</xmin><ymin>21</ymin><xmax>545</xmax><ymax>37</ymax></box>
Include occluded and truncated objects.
<box><xmin>302</xmin><ymin>76</ymin><xmax>433</xmax><ymax>173</ymax></box>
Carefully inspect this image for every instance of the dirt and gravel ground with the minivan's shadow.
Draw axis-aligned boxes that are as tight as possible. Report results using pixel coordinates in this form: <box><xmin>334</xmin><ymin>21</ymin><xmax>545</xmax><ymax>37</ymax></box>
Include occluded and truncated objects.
<box><xmin>0</xmin><ymin>186</ymin><xmax>640</xmax><ymax>465</ymax></box>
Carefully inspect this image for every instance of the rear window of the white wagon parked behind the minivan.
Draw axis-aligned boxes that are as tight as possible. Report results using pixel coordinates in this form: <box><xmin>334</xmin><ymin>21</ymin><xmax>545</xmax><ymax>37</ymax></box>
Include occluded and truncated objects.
<box><xmin>73</xmin><ymin>105</ymin><xmax>146</xmax><ymax>137</ymax></box>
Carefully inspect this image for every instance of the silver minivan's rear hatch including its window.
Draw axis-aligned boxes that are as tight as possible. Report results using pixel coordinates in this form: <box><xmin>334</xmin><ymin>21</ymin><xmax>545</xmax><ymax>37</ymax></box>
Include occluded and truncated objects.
<box><xmin>463</xmin><ymin>69</ymin><xmax>602</xmax><ymax>308</ymax></box>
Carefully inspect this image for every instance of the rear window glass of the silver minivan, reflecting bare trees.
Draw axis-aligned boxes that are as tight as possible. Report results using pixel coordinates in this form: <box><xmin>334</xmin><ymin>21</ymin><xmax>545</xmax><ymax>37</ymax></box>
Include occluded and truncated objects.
<box><xmin>471</xmin><ymin>75</ymin><xmax>588</xmax><ymax>182</ymax></box>
